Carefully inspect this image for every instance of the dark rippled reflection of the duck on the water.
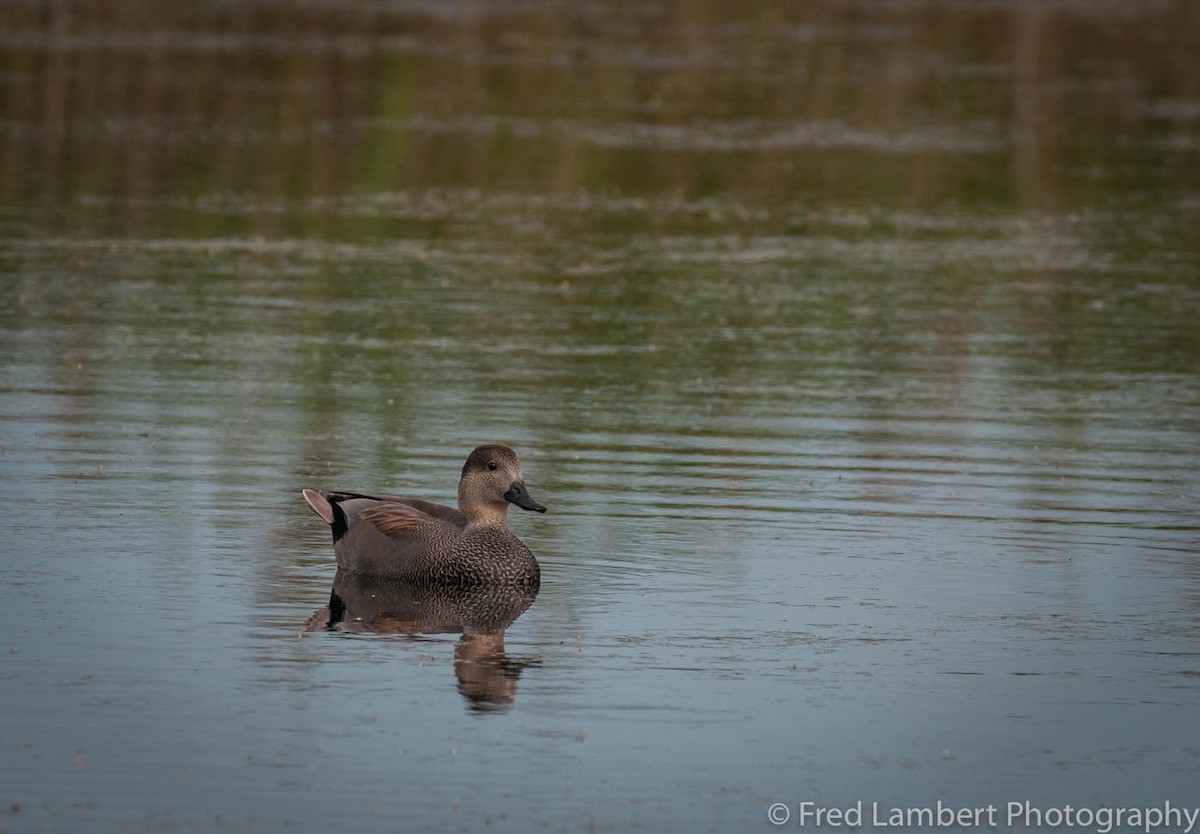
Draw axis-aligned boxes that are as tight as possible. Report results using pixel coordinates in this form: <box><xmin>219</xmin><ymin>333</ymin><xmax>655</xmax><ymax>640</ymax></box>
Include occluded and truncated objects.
<box><xmin>304</xmin><ymin>570</ymin><xmax>538</xmax><ymax>710</ymax></box>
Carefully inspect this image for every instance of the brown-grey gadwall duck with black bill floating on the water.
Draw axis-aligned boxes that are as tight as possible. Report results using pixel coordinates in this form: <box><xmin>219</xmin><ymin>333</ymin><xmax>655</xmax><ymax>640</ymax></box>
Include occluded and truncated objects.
<box><xmin>304</xmin><ymin>445</ymin><xmax>546</xmax><ymax>588</ymax></box>
